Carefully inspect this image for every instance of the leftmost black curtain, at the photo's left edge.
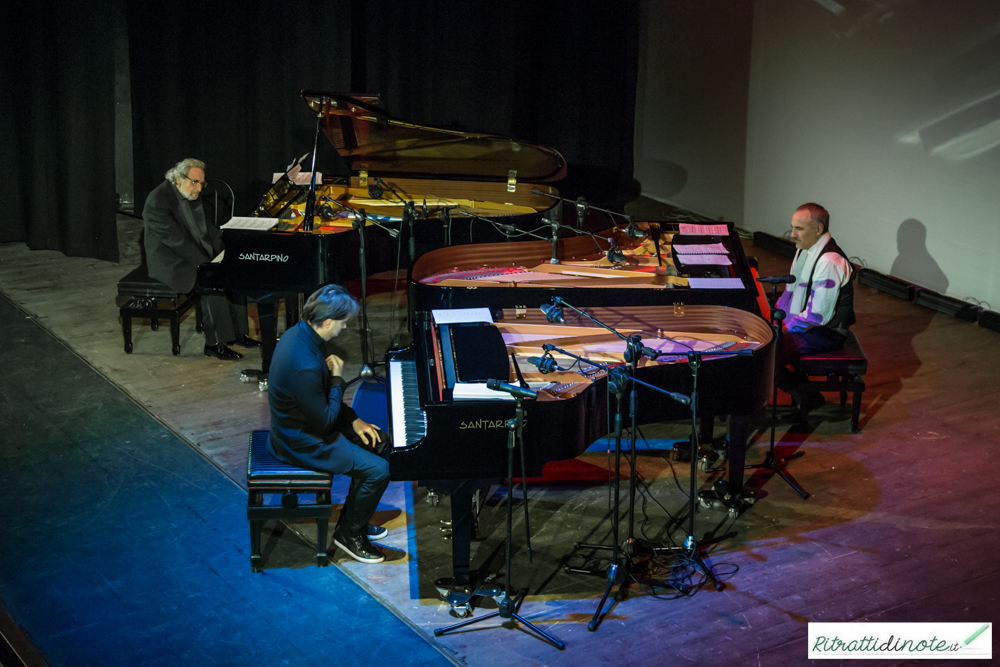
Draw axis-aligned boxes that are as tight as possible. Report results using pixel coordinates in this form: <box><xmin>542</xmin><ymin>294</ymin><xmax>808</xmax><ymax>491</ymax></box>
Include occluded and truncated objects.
<box><xmin>0</xmin><ymin>0</ymin><xmax>118</xmax><ymax>261</ymax></box>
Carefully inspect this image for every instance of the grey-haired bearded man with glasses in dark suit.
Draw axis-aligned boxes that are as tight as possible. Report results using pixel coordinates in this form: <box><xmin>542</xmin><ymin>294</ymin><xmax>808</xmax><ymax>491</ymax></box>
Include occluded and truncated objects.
<box><xmin>142</xmin><ymin>158</ymin><xmax>260</xmax><ymax>361</ymax></box>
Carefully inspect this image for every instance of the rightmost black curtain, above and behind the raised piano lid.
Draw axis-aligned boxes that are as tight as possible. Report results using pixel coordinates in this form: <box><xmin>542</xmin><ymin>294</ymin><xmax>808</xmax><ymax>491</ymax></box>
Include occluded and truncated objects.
<box><xmin>359</xmin><ymin>0</ymin><xmax>639</xmax><ymax>201</ymax></box>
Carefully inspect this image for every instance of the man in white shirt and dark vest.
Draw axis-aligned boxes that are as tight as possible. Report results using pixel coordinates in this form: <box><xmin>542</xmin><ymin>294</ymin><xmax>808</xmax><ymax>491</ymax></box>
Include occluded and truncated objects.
<box><xmin>776</xmin><ymin>203</ymin><xmax>856</xmax><ymax>421</ymax></box>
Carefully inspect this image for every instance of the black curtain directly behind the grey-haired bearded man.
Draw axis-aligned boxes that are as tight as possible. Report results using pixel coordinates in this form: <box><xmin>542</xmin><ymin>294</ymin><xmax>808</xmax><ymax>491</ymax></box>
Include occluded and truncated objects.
<box><xmin>128</xmin><ymin>0</ymin><xmax>351</xmax><ymax>215</ymax></box>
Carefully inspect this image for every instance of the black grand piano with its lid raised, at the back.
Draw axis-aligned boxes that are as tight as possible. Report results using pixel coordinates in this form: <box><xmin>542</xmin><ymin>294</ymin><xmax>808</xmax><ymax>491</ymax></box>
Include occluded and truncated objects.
<box><xmin>197</xmin><ymin>92</ymin><xmax>566</xmax><ymax>376</ymax></box>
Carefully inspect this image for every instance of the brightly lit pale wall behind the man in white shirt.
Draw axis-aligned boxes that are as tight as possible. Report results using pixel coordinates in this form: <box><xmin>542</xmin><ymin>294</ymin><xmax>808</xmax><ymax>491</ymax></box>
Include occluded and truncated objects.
<box><xmin>743</xmin><ymin>0</ymin><xmax>1000</xmax><ymax>310</ymax></box>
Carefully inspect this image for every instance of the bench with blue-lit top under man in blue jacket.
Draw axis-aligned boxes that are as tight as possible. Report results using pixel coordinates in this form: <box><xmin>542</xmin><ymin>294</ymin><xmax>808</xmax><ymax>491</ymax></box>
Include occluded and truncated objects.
<box><xmin>247</xmin><ymin>431</ymin><xmax>333</xmax><ymax>572</ymax></box>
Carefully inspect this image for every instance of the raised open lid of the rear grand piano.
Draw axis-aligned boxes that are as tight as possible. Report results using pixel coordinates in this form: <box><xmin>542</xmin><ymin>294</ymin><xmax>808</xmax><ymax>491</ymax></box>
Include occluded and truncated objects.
<box><xmin>302</xmin><ymin>90</ymin><xmax>566</xmax><ymax>183</ymax></box>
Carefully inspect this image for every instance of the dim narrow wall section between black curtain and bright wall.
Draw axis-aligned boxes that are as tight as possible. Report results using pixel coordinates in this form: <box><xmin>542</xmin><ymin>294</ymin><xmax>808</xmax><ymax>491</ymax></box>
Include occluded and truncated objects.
<box><xmin>636</xmin><ymin>0</ymin><xmax>752</xmax><ymax>223</ymax></box>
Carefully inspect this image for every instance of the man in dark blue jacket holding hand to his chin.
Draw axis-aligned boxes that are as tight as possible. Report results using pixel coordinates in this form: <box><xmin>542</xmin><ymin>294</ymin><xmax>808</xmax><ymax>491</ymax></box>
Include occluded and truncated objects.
<box><xmin>267</xmin><ymin>285</ymin><xmax>390</xmax><ymax>563</ymax></box>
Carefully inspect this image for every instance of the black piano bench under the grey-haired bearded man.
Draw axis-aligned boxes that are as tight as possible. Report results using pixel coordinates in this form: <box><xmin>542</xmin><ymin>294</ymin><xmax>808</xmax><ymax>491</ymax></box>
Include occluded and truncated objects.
<box><xmin>118</xmin><ymin>264</ymin><xmax>203</xmax><ymax>357</ymax></box>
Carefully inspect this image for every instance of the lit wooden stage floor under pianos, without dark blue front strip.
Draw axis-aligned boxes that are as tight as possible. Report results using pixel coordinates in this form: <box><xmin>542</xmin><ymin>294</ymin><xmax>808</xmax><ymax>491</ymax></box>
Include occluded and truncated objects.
<box><xmin>0</xmin><ymin>217</ymin><xmax>1000</xmax><ymax>667</ymax></box>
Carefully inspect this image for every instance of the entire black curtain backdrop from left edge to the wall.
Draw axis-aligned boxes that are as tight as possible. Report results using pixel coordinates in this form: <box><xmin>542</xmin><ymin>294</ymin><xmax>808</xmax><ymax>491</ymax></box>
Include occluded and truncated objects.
<box><xmin>0</xmin><ymin>0</ymin><xmax>639</xmax><ymax>259</ymax></box>
